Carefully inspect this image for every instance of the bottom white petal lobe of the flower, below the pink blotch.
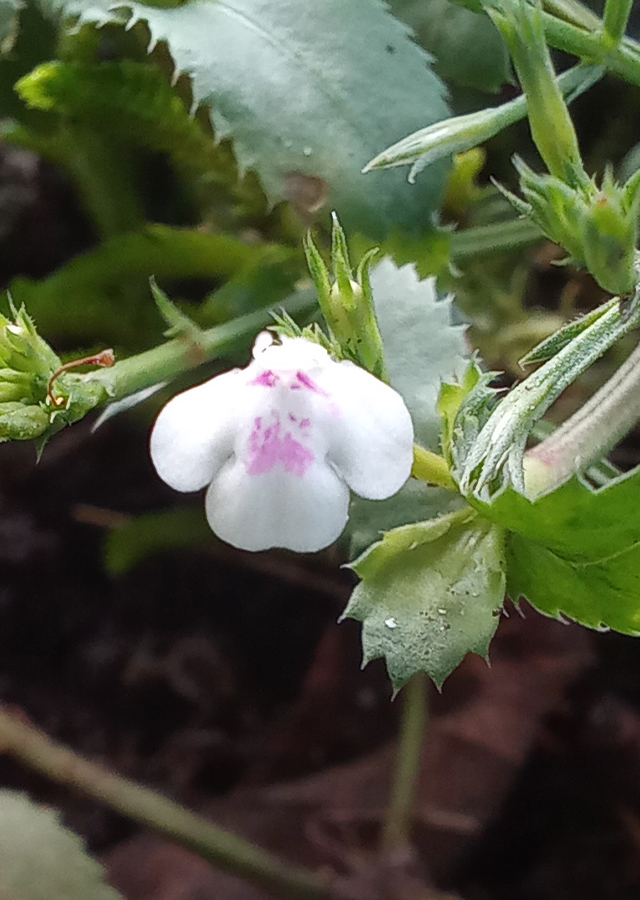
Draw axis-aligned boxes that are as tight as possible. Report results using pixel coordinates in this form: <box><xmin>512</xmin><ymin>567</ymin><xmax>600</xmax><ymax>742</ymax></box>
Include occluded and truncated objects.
<box><xmin>206</xmin><ymin>458</ymin><xmax>349</xmax><ymax>553</ymax></box>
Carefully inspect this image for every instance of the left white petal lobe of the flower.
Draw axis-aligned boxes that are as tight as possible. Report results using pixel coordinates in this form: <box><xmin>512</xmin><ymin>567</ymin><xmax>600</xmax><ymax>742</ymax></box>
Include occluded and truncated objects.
<box><xmin>149</xmin><ymin>369</ymin><xmax>244</xmax><ymax>491</ymax></box>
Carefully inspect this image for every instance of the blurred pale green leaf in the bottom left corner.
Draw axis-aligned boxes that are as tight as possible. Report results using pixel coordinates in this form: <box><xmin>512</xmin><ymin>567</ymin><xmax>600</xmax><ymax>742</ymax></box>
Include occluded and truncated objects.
<box><xmin>0</xmin><ymin>790</ymin><xmax>122</xmax><ymax>900</ymax></box>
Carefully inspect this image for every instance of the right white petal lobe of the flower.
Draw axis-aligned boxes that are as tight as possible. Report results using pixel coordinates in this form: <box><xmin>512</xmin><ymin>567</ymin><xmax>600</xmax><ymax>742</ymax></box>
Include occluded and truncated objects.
<box><xmin>319</xmin><ymin>361</ymin><xmax>413</xmax><ymax>500</ymax></box>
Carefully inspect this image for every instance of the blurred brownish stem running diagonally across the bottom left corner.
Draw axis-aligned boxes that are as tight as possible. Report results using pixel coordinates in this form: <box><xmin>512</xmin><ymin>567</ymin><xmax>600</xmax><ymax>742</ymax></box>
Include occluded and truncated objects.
<box><xmin>0</xmin><ymin>706</ymin><xmax>335</xmax><ymax>900</ymax></box>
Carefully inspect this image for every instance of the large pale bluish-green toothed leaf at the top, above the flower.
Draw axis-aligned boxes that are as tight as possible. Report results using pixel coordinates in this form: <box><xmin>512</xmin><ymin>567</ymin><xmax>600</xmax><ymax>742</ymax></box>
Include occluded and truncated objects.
<box><xmin>40</xmin><ymin>0</ymin><xmax>448</xmax><ymax>239</ymax></box>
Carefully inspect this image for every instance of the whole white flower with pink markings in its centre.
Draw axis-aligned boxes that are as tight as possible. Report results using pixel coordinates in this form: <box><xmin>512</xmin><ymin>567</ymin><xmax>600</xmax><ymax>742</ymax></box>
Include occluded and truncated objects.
<box><xmin>151</xmin><ymin>333</ymin><xmax>413</xmax><ymax>552</ymax></box>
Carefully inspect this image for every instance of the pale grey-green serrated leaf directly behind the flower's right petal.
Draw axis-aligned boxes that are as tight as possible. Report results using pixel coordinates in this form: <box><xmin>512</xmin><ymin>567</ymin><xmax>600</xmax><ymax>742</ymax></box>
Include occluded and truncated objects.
<box><xmin>349</xmin><ymin>259</ymin><xmax>467</xmax><ymax>553</ymax></box>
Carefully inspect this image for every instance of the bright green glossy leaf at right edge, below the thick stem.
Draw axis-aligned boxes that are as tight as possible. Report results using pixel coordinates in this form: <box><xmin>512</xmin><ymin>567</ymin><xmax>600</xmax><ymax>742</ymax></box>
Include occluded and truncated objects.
<box><xmin>477</xmin><ymin>469</ymin><xmax>640</xmax><ymax>634</ymax></box>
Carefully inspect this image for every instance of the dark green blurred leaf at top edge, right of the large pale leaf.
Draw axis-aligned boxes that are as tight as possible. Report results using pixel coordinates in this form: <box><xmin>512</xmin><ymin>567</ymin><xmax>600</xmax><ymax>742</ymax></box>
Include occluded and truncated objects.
<box><xmin>391</xmin><ymin>0</ymin><xmax>513</xmax><ymax>93</ymax></box>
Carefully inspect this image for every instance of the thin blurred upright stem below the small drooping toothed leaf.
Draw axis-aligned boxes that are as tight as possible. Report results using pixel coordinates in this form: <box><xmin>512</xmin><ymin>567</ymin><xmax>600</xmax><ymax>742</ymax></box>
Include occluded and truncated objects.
<box><xmin>380</xmin><ymin>672</ymin><xmax>428</xmax><ymax>854</ymax></box>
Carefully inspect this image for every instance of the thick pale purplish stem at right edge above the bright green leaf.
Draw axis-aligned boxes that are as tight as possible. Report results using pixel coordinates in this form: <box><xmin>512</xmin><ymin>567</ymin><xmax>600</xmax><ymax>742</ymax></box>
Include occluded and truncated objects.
<box><xmin>524</xmin><ymin>338</ymin><xmax>640</xmax><ymax>496</ymax></box>
